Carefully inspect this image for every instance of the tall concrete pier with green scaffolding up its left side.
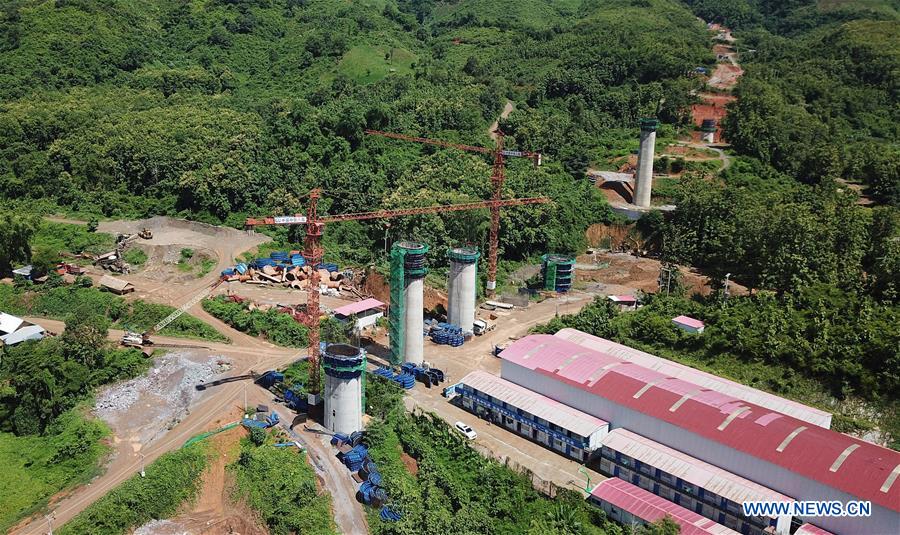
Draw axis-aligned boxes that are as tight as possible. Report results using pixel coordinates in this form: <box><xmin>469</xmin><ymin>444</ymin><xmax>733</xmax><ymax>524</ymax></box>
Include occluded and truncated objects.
<box><xmin>388</xmin><ymin>241</ymin><xmax>428</xmax><ymax>365</ymax></box>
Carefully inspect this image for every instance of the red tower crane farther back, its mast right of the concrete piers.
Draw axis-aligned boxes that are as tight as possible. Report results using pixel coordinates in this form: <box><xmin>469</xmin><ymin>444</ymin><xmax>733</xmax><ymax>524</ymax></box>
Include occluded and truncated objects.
<box><xmin>366</xmin><ymin>129</ymin><xmax>541</xmax><ymax>296</ymax></box>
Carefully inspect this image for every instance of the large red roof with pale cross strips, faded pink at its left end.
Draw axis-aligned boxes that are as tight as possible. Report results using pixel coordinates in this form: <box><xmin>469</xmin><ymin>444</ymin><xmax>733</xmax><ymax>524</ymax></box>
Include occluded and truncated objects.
<box><xmin>500</xmin><ymin>334</ymin><xmax>900</xmax><ymax>512</ymax></box>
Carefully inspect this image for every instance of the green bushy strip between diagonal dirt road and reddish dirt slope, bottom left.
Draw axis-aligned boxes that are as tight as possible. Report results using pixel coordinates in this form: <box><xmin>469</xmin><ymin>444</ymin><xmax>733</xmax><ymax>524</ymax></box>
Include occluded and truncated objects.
<box><xmin>59</xmin><ymin>443</ymin><xmax>209</xmax><ymax>535</ymax></box>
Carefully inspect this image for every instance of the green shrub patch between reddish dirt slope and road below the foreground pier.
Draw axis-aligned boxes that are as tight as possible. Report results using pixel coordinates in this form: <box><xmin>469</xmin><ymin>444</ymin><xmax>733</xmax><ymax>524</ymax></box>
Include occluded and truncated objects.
<box><xmin>229</xmin><ymin>436</ymin><xmax>337</xmax><ymax>535</ymax></box>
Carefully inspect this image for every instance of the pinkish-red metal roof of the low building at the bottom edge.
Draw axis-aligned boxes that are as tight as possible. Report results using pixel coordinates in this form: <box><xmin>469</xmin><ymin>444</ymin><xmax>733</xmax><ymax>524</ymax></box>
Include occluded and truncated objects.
<box><xmin>591</xmin><ymin>477</ymin><xmax>738</xmax><ymax>535</ymax></box>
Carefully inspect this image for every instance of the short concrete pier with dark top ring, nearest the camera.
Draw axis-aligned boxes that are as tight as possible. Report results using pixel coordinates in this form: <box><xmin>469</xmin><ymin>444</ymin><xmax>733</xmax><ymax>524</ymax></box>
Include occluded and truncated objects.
<box><xmin>322</xmin><ymin>344</ymin><xmax>366</xmax><ymax>435</ymax></box>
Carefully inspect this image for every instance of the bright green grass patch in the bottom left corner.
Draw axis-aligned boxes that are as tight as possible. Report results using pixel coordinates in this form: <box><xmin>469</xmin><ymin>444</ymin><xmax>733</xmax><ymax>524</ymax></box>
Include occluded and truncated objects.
<box><xmin>0</xmin><ymin>408</ymin><xmax>109</xmax><ymax>533</ymax></box>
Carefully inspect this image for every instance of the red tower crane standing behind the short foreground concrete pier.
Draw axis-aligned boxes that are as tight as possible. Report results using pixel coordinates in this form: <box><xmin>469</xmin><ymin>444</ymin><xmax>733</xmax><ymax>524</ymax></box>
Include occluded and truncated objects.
<box><xmin>244</xmin><ymin>188</ymin><xmax>550</xmax><ymax>405</ymax></box>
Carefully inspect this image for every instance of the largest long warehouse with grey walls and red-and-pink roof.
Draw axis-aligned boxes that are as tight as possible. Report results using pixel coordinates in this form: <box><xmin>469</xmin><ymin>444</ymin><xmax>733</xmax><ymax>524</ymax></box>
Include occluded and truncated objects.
<box><xmin>500</xmin><ymin>335</ymin><xmax>900</xmax><ymax>535</ymax></box>
